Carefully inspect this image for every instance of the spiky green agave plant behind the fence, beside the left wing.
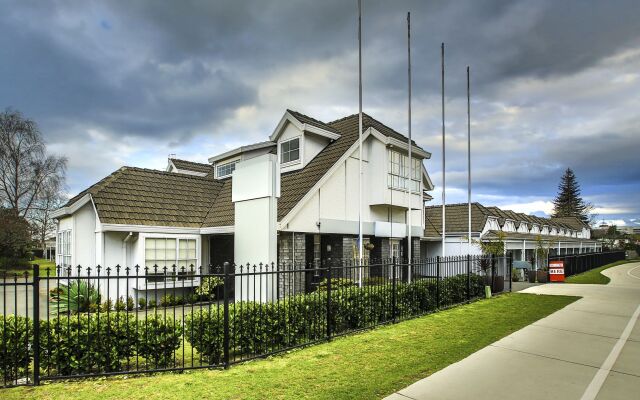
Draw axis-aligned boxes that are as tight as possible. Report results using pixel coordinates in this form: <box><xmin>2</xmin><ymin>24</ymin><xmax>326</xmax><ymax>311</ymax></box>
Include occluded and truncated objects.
<box><xmin>49</xmin><ymin>281</ymin><xmax>100</xmax><ymax>314</ymax></box>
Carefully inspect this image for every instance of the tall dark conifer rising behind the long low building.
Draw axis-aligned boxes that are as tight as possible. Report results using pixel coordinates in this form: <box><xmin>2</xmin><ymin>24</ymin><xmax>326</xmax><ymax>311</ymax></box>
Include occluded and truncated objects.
<box><xmin>551</xmin><ymin>168</ymin><xmax>593</xmax><ymax>224</ymax></box>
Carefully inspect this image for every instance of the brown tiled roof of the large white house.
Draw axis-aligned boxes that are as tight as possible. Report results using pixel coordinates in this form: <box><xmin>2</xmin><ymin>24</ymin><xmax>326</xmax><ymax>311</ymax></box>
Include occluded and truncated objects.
<box><xmin>60</xmin><ymin>111</ymin><xmax>428</xmax><ymax>228</ymax></box>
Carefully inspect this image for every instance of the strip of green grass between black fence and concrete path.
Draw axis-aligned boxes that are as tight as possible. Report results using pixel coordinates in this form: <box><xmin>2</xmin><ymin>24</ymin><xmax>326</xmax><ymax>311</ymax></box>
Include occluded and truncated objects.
<box><xmin>0</xmin><ymin>293</ymin><xmax>578</xmax><ymax>400</ymax></box>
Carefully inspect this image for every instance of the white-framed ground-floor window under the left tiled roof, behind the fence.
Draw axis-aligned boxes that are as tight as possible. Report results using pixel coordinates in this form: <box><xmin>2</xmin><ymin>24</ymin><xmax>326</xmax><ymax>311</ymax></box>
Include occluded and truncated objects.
<box><xmin>144</xmin><ymin>238</ymin><xmax>198</xmax><ymax>282</ymax></box>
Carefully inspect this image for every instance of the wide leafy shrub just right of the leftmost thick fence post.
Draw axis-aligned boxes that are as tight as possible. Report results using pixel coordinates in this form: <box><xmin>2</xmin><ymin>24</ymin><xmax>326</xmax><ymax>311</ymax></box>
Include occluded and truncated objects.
<box><xmin>40</xmin><ymin>312</ymin><xmax>138</xmax><ymax>375</ymax></box>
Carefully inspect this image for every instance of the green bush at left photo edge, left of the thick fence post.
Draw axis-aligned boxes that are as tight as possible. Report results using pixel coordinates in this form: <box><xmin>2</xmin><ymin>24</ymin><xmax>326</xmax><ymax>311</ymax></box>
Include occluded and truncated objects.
<box><xmin>0</xmin><ymin>315</ymin><xmax>33</xmax><ymax>383</ymax></box>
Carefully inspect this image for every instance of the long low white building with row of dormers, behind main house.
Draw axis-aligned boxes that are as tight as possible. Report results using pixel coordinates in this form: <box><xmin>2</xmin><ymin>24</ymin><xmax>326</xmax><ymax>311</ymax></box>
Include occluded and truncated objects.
<box><xmin>421</xmin><ymin>203</ymin><xmax>601</xmax><ymax>261</ymax></box>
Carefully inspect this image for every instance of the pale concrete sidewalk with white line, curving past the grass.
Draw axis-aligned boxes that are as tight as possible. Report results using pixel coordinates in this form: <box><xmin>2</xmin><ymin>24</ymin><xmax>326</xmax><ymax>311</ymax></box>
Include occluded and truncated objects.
<box><xmin>387</xmin><ymin>263</ymin><xmax>640</xmax><ymax>400</ymax></box>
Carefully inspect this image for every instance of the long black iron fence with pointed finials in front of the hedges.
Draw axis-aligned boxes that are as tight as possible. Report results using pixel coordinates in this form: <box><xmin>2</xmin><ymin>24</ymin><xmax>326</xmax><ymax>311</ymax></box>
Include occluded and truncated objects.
<box><xmin>0</xmin><ymin>256</ymin><xmax>512</xmax><ymax>387</ymax></box>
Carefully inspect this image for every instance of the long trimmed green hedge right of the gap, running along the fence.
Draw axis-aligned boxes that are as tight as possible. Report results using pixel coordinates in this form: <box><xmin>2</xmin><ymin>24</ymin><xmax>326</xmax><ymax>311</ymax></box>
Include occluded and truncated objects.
<box><xmin>185</xmin><ymin>274</ymin><xmax>484</xmax><ymax>364</ymax></box>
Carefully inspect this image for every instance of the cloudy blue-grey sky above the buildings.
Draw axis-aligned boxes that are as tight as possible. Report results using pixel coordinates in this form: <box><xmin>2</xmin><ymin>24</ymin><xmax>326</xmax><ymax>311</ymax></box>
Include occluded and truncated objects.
<box><xmin>0</xmin><ymin>0</ymin><xmax>640</xmax><ymax>225</ymax></box>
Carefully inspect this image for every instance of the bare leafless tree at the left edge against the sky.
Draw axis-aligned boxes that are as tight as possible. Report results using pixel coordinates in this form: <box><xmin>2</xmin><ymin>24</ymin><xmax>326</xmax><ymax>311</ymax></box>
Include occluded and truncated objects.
<box><xmin>0</xmin><ymin>109</ymin><xmax>67</xmax><ymax>219</ymax></box>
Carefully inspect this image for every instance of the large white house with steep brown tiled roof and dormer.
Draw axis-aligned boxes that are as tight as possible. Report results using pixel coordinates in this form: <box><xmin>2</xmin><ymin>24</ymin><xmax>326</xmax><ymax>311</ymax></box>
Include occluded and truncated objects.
<box><xmin>55</xmin><ymin>110</ymin><xmax>433</xmax><ymax>296</ymax></box>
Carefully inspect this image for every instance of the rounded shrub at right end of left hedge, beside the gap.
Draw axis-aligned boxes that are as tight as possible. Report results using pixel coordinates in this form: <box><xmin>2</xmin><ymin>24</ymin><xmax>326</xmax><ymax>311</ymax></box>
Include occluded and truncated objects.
<box><xmin>138</xmin><ymin>314</ymin><xmax>182</xmax><ymax>368</ymax></box>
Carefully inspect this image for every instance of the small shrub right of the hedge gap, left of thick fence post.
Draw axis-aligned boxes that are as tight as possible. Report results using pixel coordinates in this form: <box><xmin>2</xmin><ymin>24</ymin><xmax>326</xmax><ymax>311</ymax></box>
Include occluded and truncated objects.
<box><xmin>185</xmin><ymin>307</ymin><xmax>224</xmax><ymax>365</ymax></box>
